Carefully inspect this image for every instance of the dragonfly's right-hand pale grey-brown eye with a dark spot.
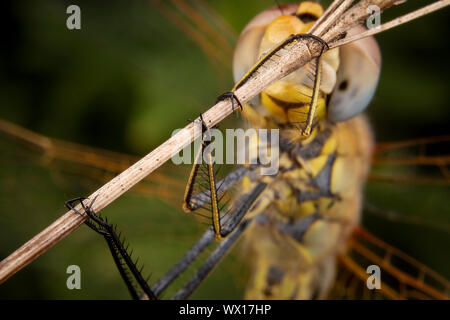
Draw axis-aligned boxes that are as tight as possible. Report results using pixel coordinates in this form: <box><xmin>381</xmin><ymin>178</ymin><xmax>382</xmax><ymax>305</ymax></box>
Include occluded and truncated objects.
<box><xmin>328</xmin><ymin>27</ymin><xmax>381</xmax><ymax>122</ymax></box>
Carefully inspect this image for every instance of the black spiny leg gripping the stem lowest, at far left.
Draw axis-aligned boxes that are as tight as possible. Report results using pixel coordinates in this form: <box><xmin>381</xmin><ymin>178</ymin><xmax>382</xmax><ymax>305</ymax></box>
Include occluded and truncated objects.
<box><xmin>65</xmin><ymin>197</ymin><xmax>156</xmax><ymax>300</ymax></box>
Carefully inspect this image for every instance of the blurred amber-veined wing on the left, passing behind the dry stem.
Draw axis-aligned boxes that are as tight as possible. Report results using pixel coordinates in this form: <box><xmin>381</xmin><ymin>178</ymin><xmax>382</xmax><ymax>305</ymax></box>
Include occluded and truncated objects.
<box><xmin>0</xmin><ymin>119</ymin><xmax>187</xmax><ymax>204</ymax></box>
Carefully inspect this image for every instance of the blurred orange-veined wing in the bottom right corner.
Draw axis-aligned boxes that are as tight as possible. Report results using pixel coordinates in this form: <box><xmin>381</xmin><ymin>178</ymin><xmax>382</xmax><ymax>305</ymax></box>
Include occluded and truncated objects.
<box><xmin>331</xmin><ymin>229</ymin><xmax>450</xmax><ymax>299</ymax></box>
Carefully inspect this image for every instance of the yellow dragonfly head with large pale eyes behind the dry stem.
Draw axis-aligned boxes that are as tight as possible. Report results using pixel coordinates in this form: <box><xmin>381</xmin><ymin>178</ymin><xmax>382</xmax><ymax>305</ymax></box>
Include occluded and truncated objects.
<box><xmin>233</xmin><ymin>1</ymin><xmax>381</xmax><ymax>130</ymax></box>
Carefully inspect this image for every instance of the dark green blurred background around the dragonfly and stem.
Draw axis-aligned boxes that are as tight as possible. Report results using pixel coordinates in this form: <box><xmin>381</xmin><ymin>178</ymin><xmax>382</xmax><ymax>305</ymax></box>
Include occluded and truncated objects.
<box><xmin>0</xmin><ymin>0</ymin><xmax>450</xmax><ymax>299</ymax></box>
